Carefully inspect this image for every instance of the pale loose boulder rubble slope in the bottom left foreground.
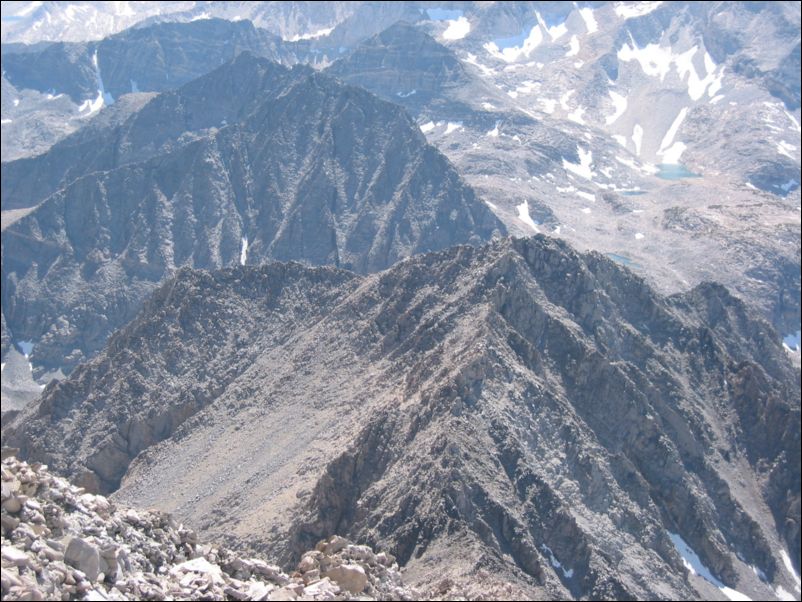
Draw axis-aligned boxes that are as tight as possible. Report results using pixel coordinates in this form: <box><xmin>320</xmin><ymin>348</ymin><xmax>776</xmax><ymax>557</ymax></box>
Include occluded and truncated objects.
<box><xmin>0</xmin><ymin>448</ymin><xmax>418</xmax><ymax>600</ymax></box>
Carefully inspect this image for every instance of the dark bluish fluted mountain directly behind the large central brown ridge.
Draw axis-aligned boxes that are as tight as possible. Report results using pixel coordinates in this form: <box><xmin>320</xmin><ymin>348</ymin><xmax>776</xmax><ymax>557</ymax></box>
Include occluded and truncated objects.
<box><xmin>2</xmin><ymin>53</ymin><xmax>505</xmax><ymax>372</ymax></box>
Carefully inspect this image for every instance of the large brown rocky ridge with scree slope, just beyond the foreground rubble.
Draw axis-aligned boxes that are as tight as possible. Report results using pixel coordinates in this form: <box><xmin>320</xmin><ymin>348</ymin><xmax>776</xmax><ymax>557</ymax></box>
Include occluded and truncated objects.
<box><xmin>3</xmin><ymin>236</ymin><xmax>800</xmax><ymax>599</ymax></box>
